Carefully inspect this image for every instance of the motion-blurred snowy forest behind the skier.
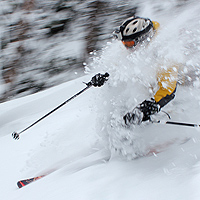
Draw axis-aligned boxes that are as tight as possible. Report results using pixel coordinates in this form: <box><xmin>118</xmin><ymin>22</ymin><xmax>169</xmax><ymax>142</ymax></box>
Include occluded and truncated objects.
<box><xmin>0</xmin><ymin>0</ymin><xmax>190</xmax><ymax>102</ymax></box>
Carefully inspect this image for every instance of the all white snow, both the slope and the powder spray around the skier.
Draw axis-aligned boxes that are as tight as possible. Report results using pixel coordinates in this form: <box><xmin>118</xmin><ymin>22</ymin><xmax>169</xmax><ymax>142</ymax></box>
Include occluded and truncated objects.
<box><xmin>0</xmin><ymin>1</ymin><xmax>200</xmax><ymax>200</ymax></box>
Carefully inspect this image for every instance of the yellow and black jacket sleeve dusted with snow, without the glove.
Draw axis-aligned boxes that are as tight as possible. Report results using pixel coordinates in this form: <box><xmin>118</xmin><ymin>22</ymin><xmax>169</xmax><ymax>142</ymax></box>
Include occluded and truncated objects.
<box><xmin>154</xmin><ymin>65</ymin><xmax>178</xmax><ymax>108</ymax></box>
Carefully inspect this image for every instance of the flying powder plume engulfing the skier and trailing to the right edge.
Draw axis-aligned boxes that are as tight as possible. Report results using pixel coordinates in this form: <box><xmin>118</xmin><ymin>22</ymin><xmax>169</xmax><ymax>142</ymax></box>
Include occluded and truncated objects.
<box><xmin>86</xmin><ymin>1</ymin><xmax>200</xmax><ymax>160</ymax></box>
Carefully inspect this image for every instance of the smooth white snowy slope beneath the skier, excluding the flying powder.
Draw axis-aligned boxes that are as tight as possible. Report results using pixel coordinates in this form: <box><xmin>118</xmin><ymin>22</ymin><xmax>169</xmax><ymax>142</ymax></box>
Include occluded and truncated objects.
<box><xmin>0</xmin><ymin>76</ymin><xmax>200</xmax><ymax>200</ymax></box>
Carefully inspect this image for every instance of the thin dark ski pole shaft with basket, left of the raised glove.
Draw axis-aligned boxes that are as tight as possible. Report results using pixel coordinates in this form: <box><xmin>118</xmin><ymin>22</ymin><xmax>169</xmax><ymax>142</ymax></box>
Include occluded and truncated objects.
<box><xmin>12</xmin><ymin>85</ymin><xmax>92</xmax><ymax>140</ymax></box>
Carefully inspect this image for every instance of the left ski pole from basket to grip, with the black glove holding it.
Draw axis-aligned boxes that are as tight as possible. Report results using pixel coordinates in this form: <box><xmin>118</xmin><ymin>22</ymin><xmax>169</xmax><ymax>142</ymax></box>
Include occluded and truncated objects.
<box><xmin>12</xmin><ymin>73</ymin><xmax>109</xmax><ymax>140</ymax></box>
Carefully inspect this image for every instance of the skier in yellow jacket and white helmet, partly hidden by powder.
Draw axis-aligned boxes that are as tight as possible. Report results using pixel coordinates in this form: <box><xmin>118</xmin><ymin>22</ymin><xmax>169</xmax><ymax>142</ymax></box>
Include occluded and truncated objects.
<box><xmin>93</xmin><ymin>16</ymin><xmax>178</xmax><ymax>125</ymax></box>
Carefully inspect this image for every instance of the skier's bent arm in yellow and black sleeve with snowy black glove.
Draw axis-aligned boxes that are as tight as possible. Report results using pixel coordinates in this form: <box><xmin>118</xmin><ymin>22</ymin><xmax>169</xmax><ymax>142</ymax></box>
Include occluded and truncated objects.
<box><xmin>123</xmin><ymin>66</ymin><xmax>178</xmax><ymax>125</ymax></box>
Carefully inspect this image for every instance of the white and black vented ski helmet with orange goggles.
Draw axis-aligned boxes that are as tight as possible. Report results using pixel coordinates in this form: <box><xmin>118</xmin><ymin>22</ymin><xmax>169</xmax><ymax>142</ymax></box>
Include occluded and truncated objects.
<box><xmin>113</xmin><ymin>16</ymin><xmax>154</xmax><ymax>48</ymax></box>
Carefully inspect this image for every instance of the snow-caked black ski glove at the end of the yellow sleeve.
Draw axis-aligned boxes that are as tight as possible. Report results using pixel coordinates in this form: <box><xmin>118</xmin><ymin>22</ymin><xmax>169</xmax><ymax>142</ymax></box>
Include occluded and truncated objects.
<box><xmin>123</xmin><ymin>99</ymin><xmax>160</xmax><ymax>125</ymax></box>
